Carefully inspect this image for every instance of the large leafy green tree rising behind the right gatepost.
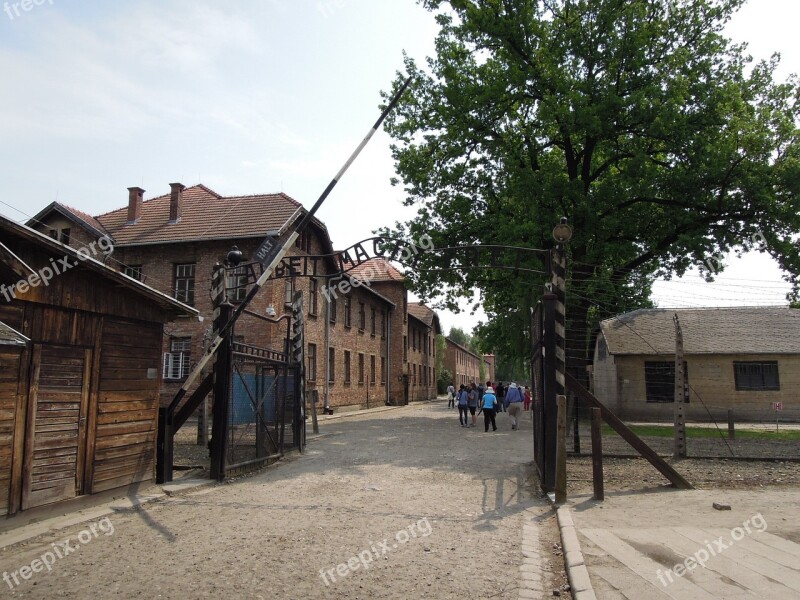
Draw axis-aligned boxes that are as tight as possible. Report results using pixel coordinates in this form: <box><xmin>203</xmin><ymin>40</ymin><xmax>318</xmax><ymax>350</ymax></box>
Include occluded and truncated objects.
<box><xmin>385</xmin><ymin>0</ymin><xmax>800</xmax><ymax>376</ymax></box>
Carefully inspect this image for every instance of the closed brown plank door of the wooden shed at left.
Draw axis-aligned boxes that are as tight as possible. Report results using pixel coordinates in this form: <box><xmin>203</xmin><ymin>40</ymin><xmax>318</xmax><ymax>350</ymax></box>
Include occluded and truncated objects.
<box><xmin>22</xmin><ymin>345</ymin><xmax>92</xmax><ymax>510</ymax></box>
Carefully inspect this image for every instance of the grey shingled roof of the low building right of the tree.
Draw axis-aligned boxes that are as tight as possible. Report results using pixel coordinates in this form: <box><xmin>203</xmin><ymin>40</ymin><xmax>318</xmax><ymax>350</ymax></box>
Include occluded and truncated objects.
<box><xmin>600</xmin><ymin>307</ymin><xmax>800</xmax><ymax>355</ymax></box>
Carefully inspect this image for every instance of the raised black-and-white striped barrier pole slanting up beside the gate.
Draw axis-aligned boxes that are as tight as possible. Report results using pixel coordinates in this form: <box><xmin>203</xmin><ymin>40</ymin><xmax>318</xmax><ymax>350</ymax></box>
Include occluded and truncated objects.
<box><xmin>170</xmin><ymin>77</ymin><xmax>412</xmax><ymax>410</ymax></box>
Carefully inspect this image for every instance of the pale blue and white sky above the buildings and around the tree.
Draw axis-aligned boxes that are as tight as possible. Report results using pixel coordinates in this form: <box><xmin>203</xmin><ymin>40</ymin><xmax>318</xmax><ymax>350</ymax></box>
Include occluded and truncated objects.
<box><xmin>0</xmin><ymin>0</ymin><xmax>800</xmax><ymax>338</ymax></box>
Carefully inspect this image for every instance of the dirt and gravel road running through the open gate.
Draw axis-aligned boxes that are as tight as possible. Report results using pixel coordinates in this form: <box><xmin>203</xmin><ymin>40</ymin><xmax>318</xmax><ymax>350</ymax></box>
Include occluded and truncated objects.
<box><xmin>0</xmin><ymin>403</ymin><xmax>569</xmax><ymax>600</ymax></box>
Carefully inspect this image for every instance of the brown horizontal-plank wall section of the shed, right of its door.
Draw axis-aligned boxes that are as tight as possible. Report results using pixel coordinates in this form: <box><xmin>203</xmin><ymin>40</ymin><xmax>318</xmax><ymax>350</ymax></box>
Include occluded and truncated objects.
<box><xmin>87</xmin><ymin>317</ymin><xmax>162</xmax><ymax>493</ymax></box>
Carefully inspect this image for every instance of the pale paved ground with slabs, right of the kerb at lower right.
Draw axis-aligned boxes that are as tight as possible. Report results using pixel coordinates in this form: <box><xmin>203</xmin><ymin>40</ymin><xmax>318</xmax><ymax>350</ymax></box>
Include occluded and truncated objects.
<box><xmin>570</xmin><ymin>488</ymin><xmax>800</xmax><ymax>600</ymax></box>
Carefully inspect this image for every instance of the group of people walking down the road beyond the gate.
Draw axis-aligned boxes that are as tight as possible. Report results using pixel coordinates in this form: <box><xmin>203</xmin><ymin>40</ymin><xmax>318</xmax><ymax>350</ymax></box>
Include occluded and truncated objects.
<box><xmin>447</xmin><ymin>381</ymin><xmax>531</xmax><ymax>432</ymax></box>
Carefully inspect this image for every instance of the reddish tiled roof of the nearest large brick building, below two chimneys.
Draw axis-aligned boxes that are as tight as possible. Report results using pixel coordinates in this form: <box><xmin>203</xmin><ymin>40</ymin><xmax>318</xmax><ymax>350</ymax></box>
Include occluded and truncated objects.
<box><xmin>97</xmin><ymin>185</ymin><xmax>318</xmax><ymax>246</ymax></box>
